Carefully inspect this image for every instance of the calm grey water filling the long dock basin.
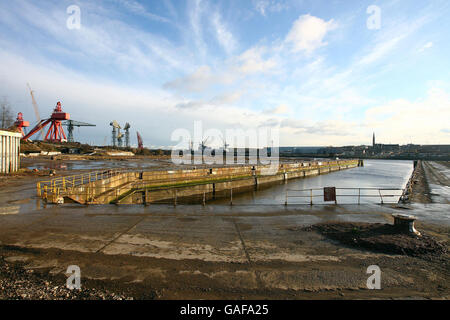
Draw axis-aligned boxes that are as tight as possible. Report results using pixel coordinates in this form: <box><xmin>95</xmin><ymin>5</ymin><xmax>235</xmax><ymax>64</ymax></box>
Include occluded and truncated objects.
<box><xmin>212</xmin><ymin>160</ymin><xmax>413</xmax><ymax>204</ymax></box>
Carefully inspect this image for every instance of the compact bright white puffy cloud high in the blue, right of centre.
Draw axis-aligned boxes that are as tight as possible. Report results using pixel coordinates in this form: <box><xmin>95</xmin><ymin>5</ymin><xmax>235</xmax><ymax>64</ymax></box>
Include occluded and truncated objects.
<box><xmin>286</xmin><ymin>14</ymin><xmax>337</xmax><ymax>54</ymax></box>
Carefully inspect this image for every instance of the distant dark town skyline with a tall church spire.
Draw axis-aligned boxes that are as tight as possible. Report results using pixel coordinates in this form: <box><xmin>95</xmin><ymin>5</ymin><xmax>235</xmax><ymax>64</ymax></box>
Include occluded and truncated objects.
<box><xmin>279</xmin><ymin>134</ymin><xmax>450</xmax><ymax>161</ymax></box>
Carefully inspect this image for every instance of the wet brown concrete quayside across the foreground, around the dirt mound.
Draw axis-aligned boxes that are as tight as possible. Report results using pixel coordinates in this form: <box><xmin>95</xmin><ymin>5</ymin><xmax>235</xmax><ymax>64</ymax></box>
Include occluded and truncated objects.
<box><xmin>0</xmin><ymin>159</ymin><xmax>450</xmax><ymax>299</ymax></box>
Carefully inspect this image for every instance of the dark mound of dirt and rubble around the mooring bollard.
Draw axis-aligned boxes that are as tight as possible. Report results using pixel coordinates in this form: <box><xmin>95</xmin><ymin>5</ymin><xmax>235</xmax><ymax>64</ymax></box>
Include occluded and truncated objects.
<box><xmin>308</xmin><ymin>222</ymin><xmax>447</xmax><ymax>256</ymax></box>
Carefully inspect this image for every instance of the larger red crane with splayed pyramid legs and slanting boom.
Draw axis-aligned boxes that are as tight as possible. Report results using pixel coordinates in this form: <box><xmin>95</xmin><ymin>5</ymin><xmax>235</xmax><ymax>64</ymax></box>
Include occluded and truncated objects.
<box><xmin>22</xmin><ymin>101</ymin><xmax>70</xmax><ymax>142</ymax></box>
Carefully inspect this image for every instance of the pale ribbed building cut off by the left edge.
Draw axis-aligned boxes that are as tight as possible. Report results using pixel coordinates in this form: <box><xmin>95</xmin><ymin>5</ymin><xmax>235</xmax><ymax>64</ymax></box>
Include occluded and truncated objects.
<box><xmin>0</xmin><ymin>130</ymin><xmax>22</xmax><ymax>173</ymax></box>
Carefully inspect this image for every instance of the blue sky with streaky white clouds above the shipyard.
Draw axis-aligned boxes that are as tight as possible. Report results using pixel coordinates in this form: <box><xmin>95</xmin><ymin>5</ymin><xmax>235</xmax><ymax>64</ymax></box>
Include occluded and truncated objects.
<box><xmin>0</xmin><ymin>0</ymin><xmax>450</xmax><ymax>147</ymax></box>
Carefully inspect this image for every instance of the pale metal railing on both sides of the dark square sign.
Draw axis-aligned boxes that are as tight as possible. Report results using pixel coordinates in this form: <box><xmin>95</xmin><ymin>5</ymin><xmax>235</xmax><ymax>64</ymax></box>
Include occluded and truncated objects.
<box><xmin>284</xmin><ymin>188</ymin><xmax>404</xmax><ymax>205</ymax></box>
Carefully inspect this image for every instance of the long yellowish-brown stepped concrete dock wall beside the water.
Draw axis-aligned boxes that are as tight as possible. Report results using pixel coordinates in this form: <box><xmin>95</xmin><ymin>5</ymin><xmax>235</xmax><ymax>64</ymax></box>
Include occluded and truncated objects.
<box><xmin>62</xmin><ymin>160</ymin><xmax>358</xmax><ymax>204</ymax></box>
